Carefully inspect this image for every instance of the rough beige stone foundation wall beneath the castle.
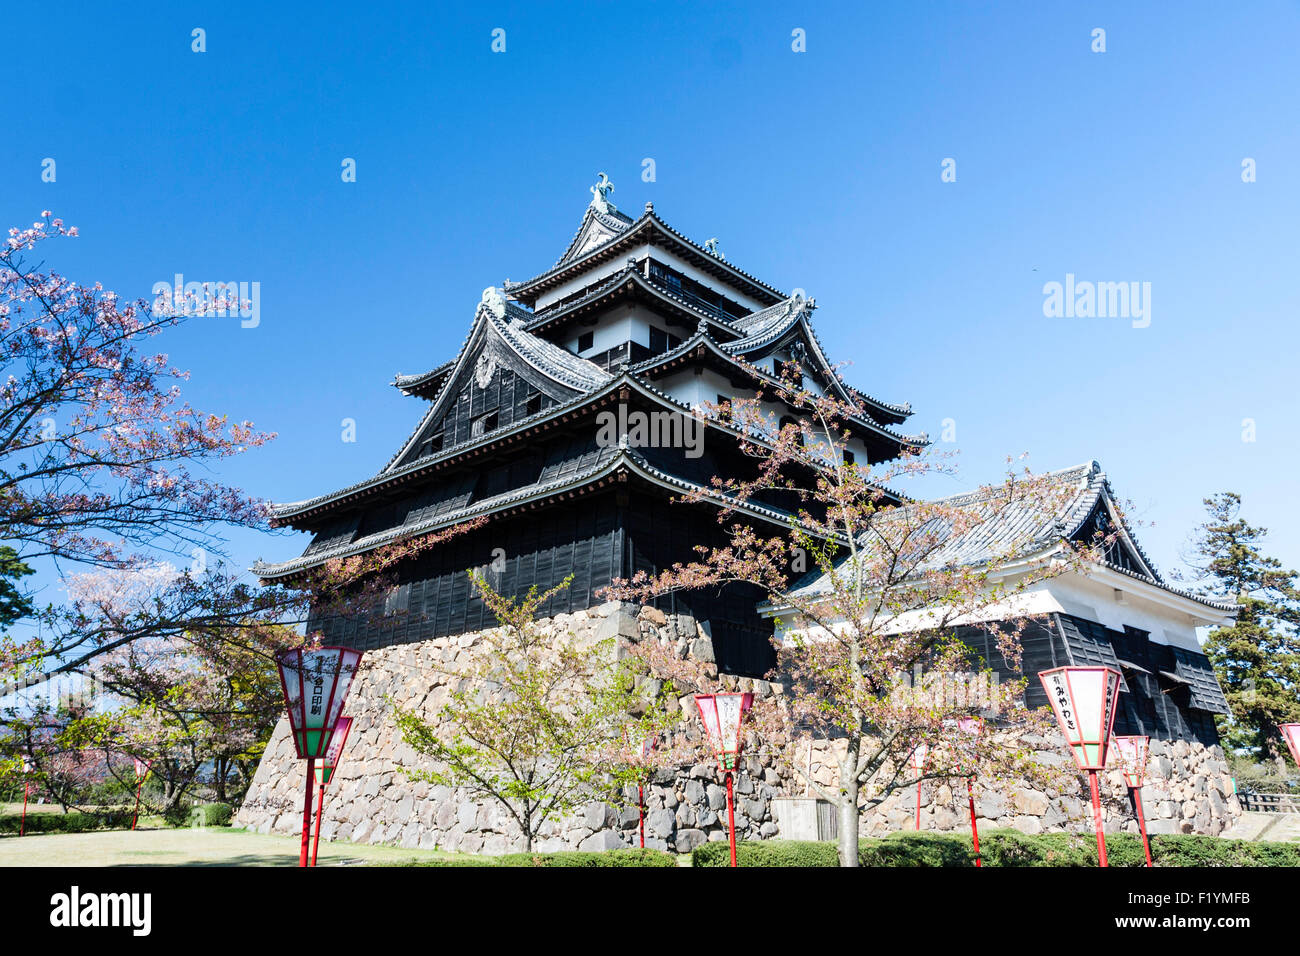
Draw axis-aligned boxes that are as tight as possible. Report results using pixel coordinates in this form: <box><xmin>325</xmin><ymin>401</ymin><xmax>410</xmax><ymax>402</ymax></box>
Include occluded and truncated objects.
<box><xmin>234</xmin><ymin>602</ymin><xmax>1240</xmax><ymax>853</ymax></box>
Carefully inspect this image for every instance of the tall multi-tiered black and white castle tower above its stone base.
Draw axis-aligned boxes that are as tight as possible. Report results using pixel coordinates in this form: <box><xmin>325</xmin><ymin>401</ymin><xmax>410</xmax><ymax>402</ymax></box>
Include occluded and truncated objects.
<box><xmin>255</xmin><ymin>177</ymin><xmax>924</xmax><ymax>676</ymax></box>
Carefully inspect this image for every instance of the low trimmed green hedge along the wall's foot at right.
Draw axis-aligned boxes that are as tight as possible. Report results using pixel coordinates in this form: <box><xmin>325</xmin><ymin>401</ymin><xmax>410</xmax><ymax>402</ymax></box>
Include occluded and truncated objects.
<box><xmin>690</xmin><ymin>830</ymin><xmax>1300</xmax><ymax>866</ymax></box>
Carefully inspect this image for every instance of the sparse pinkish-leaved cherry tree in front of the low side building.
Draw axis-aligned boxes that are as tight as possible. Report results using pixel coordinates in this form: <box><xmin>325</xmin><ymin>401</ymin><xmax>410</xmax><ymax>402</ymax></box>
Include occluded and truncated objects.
<box><xmin>607</xmin><ymin>364</ymin><xmax>1096</xmax><ymax>866</ymax></box>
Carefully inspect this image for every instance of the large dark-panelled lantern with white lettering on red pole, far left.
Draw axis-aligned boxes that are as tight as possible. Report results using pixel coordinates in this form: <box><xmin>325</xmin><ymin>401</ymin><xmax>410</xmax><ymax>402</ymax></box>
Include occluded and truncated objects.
<box><xmin>276</xmin><ymin>648</ymin><xmax>361</xmax><ymax>866</ymax></box>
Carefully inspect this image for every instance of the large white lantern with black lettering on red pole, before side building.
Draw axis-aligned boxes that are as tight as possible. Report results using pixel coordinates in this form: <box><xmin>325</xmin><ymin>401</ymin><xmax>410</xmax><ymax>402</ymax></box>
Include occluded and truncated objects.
<box><xmin>1039</xmin><ymin>667</ymin><xmax>1119</xmax><ymax>866</ymax></box>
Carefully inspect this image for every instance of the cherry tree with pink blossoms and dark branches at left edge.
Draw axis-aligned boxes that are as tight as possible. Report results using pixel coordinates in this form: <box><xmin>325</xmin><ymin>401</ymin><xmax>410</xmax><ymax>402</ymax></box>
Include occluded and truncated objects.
<box><xmin>0</xmin><ymin>212</ymin><xmax>475</xmax><ymax>787</ymax></box>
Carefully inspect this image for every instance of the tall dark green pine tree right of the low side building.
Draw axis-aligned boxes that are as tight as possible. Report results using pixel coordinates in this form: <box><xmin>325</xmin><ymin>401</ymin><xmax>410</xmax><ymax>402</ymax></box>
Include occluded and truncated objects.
<box><xmin>1195</xmin><ymin>492</ymin><xmax>1300</xmax><ymax>758</ymax></box>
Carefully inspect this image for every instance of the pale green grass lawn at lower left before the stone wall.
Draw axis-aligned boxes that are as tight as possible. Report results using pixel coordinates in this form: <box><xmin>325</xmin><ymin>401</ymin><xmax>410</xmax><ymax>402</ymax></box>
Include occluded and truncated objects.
<box><xmin>0</xmin><ymin>827</ymin><xmax>452</xmax><ymax>866</ymax></box>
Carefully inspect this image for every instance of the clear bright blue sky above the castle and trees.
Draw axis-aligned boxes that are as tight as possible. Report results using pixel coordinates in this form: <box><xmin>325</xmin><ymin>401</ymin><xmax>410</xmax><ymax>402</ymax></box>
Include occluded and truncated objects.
<box><xmin>10</xmin><ymin>1</ymin><xmax>1300</xmax><ymax>598</ymax></box>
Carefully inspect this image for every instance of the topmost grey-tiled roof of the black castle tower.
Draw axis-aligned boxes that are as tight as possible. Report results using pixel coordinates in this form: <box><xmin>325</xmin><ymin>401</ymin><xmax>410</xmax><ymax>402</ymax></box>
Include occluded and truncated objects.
<box><xmin>506</xmin><ymin>203</ymin><xmax>787</xmax><ymax>304</ymax></box>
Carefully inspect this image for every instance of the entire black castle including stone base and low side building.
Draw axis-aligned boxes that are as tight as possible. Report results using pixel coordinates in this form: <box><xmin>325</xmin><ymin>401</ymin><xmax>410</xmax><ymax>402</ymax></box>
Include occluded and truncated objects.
<box><xmin>237</xmin><ymin>173</ymin><xmax>1239</xmax><ymax>852</ymax></box>
